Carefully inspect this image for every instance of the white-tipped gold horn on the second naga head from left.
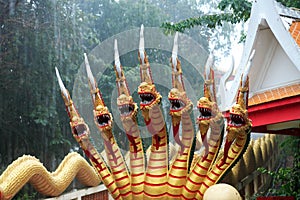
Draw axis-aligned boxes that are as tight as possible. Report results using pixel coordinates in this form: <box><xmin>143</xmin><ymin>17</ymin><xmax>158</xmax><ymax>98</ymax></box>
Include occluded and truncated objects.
<box><xmin>84</xmin><ymin>54</ymin><xmax>105</xmax><ymax>110</ymax></box>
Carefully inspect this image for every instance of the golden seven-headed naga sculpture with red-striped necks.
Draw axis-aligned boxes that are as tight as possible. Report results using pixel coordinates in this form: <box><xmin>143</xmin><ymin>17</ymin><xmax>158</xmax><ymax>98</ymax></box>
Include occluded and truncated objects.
<box><xmin>0</xmin><ymin>26</ymin><xmax>253</xmax><ymax>200</ymax></box>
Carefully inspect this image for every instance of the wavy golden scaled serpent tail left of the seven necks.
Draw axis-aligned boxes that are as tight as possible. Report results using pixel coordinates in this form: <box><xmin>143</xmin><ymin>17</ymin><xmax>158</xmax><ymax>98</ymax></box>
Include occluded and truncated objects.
<box><xmin>0</xmin><ymin>153</ymin><xmax>101</xmax><ymax>199</ymax></box>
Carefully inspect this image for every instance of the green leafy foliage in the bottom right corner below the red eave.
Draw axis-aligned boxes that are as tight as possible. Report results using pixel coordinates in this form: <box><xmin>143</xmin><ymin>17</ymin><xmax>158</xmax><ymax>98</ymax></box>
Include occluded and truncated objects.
<box><xmin>258</xmin><ymin>136</ymin><xmax>300</xmax><ymax>199</ymax></box>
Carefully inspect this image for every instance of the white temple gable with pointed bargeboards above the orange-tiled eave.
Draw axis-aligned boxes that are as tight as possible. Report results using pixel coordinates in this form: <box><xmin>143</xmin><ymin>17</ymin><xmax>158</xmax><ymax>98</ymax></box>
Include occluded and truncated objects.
<box><xmin>221</xmin><ymin>0</ymin><xmax>300</xmax><ymax>111</ymax></box>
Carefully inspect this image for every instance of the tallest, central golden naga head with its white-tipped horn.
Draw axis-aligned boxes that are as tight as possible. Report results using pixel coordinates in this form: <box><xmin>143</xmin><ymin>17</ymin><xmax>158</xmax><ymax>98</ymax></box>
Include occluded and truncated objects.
<box><xmin>138</xmin><ymin>25</ymin><xmax>162</xmax><ymax>112</ymax></box>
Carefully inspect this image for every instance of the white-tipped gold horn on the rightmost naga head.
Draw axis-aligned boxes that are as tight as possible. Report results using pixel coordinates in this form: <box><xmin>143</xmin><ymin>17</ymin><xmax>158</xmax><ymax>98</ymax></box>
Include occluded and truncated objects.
<box><xmin>237</xmin><ymin>50</ymin><xmax>255</xmax><ymax>109</ymax></box>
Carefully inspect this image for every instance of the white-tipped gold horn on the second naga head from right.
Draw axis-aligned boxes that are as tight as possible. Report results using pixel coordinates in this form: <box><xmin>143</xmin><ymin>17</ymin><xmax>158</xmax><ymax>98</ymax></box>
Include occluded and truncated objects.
<box><xmin>204</xmin><ymin>51</ymin><xmax>216</xmax><ymax>102</ymax></box>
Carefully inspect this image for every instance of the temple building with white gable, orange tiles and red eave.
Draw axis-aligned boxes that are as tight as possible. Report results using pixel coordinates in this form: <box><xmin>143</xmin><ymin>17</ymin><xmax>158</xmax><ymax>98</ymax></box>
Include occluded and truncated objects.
<box><xmin>221</xmin><ymin>0</ymin><xmax>300</xmax><ymax>135</ymax></box>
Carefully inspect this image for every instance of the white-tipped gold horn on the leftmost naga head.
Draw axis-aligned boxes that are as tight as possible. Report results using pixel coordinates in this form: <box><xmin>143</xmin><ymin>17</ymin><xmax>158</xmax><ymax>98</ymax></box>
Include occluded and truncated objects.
<box><xmin>55</xmin><ymin>67</ymin><xmax>80</xmax><ymax>122</ymax></box>
